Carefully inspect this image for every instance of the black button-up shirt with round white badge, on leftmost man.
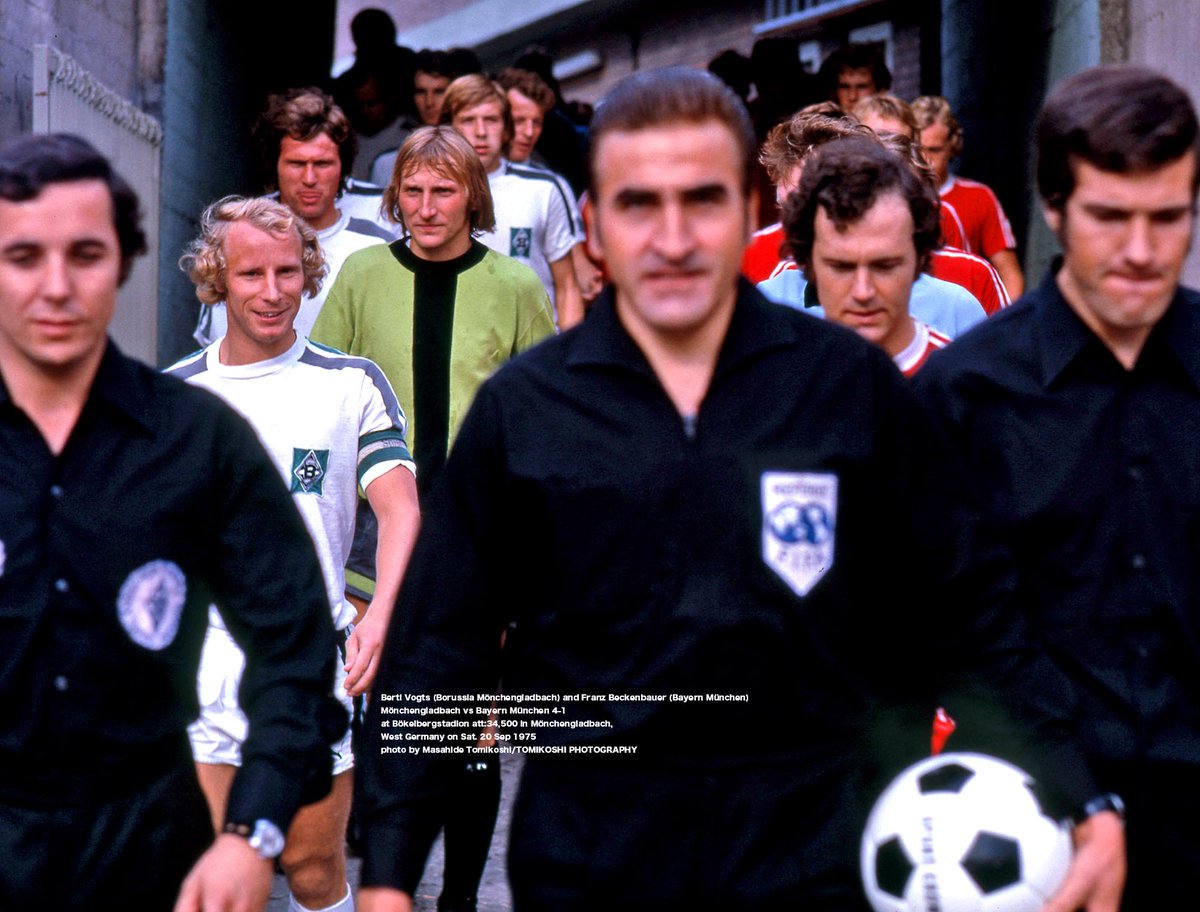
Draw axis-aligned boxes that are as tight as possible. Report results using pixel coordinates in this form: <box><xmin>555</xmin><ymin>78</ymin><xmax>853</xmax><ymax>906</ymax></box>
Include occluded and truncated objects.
<box><xmin>0</xmin><ymin>343</ymin><xmax>346</xmax><ymax>828</ymax></box>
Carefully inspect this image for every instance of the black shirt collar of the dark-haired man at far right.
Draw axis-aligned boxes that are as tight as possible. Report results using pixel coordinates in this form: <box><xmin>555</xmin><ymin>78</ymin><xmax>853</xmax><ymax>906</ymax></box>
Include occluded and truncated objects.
<box><xmin>1037</xmin><ymin>257</ymin><xmax>1200</xmax><ymax>390</ymax></box>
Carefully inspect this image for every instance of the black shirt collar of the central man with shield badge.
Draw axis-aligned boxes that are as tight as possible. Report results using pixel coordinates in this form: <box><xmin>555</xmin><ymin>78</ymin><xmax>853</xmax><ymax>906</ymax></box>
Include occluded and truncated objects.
<box><xmin>566</xmin><ymin>277</ymin><xmax>797</xmax><ymax>380</ymax></box>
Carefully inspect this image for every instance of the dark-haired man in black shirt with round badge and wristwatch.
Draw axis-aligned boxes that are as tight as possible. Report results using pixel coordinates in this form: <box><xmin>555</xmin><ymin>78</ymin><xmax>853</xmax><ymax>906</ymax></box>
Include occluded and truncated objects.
<box><xmin>0</xmin><ymin>134</ymin><xmax>346</xmax><ymax>912</ymax></box>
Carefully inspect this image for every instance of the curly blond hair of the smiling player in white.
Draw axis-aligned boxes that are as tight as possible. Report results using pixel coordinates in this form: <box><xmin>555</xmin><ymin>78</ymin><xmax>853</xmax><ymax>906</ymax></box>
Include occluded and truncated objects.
<box><xmin>179</xmin><ymin>196</ymin><xmax>328</xmax><ymax>304</ymax></box>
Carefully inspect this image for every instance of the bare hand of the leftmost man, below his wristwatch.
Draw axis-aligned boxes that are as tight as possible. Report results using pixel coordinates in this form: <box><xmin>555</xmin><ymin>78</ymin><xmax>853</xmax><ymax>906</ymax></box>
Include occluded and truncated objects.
<box><xmin>175</xmin><ymin>833</ymin><xmax>275</xmax><ymax>912</ymax></box>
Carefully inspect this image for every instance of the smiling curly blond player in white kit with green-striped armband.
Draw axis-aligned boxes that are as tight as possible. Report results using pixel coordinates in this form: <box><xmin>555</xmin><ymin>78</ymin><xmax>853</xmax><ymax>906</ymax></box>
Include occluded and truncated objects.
<box><xmin>169</xmin><ymin>197</ymin><xmax>418</xmax><ymax>912</ymax></box>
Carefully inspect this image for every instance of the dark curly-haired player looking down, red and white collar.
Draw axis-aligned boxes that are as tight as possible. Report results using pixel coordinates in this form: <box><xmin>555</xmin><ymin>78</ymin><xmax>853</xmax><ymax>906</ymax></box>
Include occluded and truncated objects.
<box><xmin>784</xmin><ymin>137</ymin><xmax>949</xmax><ymax>377</ymax></box>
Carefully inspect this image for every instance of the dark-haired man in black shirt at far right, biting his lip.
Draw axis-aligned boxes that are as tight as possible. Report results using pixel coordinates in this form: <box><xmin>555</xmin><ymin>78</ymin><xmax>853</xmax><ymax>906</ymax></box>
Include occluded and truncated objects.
<box><xmin>917</xmin><ymin>67</ymin><xmax>1200</xmax><ymax>910</ymax></box>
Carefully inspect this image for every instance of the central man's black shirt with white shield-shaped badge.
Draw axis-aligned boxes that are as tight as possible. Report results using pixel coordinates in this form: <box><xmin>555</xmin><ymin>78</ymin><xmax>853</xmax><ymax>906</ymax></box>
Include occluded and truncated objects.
<box><xmin>358</xmin><ymin>282</ymin><xmax>1094</xmax><ymax>890</ymax></box>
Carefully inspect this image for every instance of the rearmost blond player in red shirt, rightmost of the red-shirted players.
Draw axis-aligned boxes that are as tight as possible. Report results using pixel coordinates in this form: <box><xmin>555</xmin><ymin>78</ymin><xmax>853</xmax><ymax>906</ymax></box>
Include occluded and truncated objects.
<box><xmin>912</xmin><ymin>95</ymin><xmax>1025</xmax><ymax>298</ymax></box>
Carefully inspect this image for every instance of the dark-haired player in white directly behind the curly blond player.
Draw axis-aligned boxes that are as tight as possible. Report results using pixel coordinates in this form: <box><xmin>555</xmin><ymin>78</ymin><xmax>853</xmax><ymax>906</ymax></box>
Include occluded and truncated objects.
<box><xmin>193</xmin><ymin>88</ymin><xmax>392</xmax><ymax>346</ymax></box>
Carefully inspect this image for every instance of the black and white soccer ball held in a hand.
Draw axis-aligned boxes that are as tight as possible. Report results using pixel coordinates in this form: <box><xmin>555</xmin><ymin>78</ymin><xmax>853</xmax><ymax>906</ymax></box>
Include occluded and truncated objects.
<box><xmin>860</xmin><ymin>754</ymin><xmax>1070</xmax><ymax>912</ymax></box>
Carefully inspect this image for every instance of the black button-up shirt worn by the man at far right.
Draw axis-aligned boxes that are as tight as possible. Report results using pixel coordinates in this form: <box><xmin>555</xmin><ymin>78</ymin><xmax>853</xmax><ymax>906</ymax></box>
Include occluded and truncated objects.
<box><xmin>916</xmin><ymin>264</ymin><xmax>1200</xmax><ymax>763</ymax></box>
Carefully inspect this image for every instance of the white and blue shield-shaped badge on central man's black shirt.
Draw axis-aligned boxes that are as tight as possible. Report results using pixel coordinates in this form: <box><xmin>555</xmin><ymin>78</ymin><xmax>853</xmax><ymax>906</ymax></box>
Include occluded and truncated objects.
<box><xmin>762</xmin><ymin>472</ymin><xmax>838</xmax><ymax>595</ymax></box>
